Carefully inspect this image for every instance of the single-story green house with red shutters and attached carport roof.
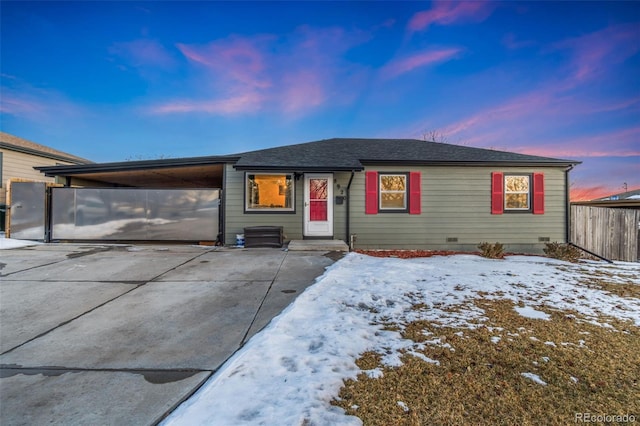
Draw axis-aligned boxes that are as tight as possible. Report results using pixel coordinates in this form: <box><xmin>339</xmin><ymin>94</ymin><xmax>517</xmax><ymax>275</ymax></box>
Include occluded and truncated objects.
<box><xmin>37</xmin><ymin>138</ymin><xmax>579</xmax><ymax>252</ymax></box>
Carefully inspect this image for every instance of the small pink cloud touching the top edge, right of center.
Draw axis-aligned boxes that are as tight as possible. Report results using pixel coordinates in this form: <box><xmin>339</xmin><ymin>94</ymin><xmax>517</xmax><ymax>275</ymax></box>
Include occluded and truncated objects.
<box><xmin>407</xmin><ymin>1</ymin><xmax>494</xmax><ymax>32</ymax></box>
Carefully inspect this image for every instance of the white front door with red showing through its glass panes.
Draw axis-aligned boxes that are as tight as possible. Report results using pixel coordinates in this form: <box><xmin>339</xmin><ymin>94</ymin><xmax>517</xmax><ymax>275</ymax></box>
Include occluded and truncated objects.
<box><xmin>304</xmin><ymin>173</ymin><xmax>333</xmax><ymax>237</ymax></box>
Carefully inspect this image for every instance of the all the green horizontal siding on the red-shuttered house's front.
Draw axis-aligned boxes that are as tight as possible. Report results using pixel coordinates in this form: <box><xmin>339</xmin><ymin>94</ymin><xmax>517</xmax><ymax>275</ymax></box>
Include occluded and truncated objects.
<box><xmin>224</xmin><ymin>165</ymin><xmax>567</xmax><ymax>252</ymax></box>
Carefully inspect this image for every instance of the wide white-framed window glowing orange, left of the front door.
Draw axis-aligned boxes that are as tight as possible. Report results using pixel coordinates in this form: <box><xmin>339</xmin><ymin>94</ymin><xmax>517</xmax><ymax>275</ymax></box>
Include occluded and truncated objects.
<box><xmin>245</xmin><ymin>173</ymin><xmax>295</xmax><ymax>212</ymax></box>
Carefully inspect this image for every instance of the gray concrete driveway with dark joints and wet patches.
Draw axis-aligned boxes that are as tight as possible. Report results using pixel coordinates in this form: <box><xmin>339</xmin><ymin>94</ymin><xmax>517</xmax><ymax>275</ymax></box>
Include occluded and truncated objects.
<box><xmin>0</xmin><ymin>244</ymin><xmax>340</xmax><ymax>425</ymax></box>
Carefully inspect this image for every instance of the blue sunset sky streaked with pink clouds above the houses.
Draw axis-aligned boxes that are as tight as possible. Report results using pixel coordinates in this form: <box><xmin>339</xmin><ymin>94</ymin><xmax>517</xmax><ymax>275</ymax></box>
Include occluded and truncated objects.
<box><xmin>0</xmin><ymin>1</ymin><xmax>640</xmax><ymax>200</ymax></box>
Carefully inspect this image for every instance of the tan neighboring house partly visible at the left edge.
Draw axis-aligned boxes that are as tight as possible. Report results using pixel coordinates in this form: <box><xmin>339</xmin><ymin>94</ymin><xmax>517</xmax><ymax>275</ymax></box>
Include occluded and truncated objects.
<box><xmin>0</xmin><ymin>132</ymin><xmax>91</xmax><ymax>231</ymax></box>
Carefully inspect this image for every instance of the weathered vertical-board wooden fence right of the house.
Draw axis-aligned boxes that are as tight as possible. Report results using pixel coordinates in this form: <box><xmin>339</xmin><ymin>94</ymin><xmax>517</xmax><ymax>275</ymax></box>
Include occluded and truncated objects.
<box><xmin>571</xmin><ymin>205</ymin><xmax>640</xmax><ymax>262</ymax></box>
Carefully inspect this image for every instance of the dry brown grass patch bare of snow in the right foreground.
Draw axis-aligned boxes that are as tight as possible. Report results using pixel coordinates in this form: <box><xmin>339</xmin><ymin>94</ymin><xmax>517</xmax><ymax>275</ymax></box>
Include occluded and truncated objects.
<box><xmin>335</xmin><ymin>298</ymin><xmax>640</xmax><ymax>426</ymax></box>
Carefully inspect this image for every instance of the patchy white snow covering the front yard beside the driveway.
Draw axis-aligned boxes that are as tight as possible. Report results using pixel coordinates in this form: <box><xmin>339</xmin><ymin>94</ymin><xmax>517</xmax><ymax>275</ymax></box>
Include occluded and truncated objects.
<box><xmin>164</xmin><ymin>253</ymin><xmax>640</xmax><ymax>425</ymax></box>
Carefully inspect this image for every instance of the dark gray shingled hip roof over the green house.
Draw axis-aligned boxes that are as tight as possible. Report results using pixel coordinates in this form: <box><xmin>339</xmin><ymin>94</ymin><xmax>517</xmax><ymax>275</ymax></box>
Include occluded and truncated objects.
<box><xmin>235</xmin><ymin>138</ymin><xmax>579</xmax><ymax>171</ymax></box>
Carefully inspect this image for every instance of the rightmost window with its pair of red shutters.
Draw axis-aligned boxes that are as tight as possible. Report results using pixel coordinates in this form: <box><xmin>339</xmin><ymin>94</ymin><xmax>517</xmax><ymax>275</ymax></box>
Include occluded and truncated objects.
<box><xmin>491</xmin><ymin>172</ymin><xmax>545</xmax><ymax>214</ymax></box>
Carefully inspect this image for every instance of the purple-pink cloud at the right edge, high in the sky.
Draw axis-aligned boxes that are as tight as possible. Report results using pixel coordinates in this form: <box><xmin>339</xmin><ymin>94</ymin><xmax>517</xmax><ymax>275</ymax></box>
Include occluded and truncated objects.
<box><xmin>553</xmin><ymin>23</ymin><xmax>640</xmax><ymax>84</ymax></box>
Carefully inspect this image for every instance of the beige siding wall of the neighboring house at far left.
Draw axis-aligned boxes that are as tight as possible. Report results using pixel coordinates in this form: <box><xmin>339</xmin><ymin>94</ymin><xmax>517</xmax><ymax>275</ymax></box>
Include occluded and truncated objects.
<box><xmin>0</xmin><ymin>148</ymin><xmax>75</xmax><ymax>204</ymax></box>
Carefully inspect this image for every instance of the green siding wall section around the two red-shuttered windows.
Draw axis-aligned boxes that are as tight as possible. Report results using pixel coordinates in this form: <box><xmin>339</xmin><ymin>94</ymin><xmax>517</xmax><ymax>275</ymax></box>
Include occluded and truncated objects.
<box><xmin>351</xmin><ymin>166</ymin><xmax>567</xmax><ymax>252</ymax></box>
